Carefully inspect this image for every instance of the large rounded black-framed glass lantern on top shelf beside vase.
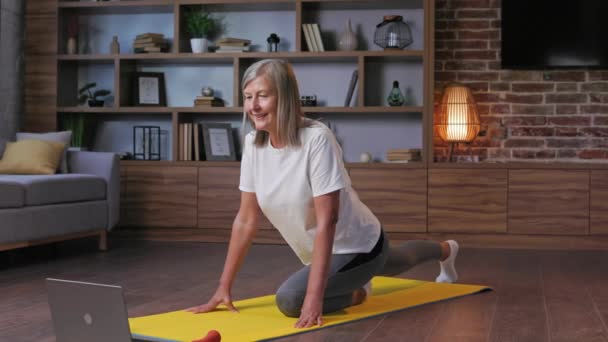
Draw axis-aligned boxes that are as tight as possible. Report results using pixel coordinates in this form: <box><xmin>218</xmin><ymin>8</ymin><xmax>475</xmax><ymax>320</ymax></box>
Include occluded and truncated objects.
<box><xmin>374</xmin><ymin>15</ymin><xmax>414</xmax><ymax>49</ymax></box>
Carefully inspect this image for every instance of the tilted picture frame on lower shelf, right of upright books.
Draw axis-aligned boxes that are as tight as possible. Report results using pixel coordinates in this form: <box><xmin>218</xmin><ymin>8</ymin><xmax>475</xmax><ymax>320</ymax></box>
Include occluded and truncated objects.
<box><xmin>203</xmin><ymin>123</ymin><xmax>236</xmax><ymax>160</ymax></box>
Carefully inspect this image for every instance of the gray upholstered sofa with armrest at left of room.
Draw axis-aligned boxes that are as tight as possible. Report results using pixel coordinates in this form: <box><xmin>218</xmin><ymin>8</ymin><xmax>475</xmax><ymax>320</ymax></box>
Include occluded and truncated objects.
<box><xmin>0</xmin><ymin>151</ymin><xmax>120</xmax><ymax>251</ymax></box>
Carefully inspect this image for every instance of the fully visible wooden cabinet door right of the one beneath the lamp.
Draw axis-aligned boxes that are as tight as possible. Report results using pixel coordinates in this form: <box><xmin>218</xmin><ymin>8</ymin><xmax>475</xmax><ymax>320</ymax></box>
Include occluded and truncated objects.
<box><xmin>508</xmin><ymin>170</ymin><xmax>589</xmax><ymax>234</ymax></box>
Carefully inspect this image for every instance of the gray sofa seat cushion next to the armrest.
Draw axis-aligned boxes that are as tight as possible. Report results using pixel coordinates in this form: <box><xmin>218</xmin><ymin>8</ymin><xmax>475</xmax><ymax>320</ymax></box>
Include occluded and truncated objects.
<box><xmin>0</xmin><ymin>173</ymin><xmax>106</xmax><ymax>206</ymax></box>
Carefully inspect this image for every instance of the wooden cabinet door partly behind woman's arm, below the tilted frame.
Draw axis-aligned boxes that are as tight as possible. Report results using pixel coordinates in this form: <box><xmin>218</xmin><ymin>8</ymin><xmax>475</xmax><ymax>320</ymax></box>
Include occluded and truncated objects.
<box><xmin>198</xmin><ymin>166</ymin><xmax>272</xmax><ymax>229</ymax></box>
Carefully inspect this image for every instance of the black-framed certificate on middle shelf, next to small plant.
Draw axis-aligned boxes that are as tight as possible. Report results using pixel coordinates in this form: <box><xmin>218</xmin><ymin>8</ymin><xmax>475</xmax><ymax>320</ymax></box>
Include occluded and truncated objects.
<box><xmin>134</xmin><ymin>72</ymin><xmax>167</xmax><ymax>107</ymax></box>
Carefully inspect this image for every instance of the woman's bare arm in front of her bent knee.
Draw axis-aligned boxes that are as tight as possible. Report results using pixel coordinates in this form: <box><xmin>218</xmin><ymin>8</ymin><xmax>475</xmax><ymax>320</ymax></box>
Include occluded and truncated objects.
<box><xmin>295</xmin><ymin>190</ymin><xmax>340</xmax><ymax>328</ymax></box>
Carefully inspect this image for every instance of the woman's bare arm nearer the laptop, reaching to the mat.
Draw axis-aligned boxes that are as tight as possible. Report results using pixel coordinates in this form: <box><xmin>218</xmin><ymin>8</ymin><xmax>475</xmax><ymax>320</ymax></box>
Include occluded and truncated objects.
<box><xmin>188</xmin><ymin>192</ymin><xmax>261</xmax><ymax>313</ymax></box>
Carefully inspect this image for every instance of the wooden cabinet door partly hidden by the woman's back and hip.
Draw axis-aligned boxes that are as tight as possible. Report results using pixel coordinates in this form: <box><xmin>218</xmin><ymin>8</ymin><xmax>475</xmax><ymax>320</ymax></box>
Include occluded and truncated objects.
<box><xmin>350</xmin><ymin>168</ymin><xmax>426</xmax><ymax>232</ymax></box>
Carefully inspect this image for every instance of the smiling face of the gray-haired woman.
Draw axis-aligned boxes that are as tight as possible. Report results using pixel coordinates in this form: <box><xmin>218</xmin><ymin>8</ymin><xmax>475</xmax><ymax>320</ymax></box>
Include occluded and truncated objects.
<box><xmin>243</xmin><ymin>76</ymin><xmax>278</xmax><ymax>135</ymax></box>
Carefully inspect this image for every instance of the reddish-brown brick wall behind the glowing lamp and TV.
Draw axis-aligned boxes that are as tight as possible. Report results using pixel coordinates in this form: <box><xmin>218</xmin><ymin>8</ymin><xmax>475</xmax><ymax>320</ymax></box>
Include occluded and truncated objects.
<box><xmin>434</xmin><ymin>0</ymin><xmax>608</xmax><ymax>162</ymax></box>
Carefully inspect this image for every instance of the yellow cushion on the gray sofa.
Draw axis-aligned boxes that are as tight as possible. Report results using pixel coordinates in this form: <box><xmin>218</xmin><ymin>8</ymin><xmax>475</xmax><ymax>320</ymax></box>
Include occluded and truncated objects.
<box><xmin>0</xmin><ymin>139</ymin><xmax>65</xmax><ymax>175</ymax></box>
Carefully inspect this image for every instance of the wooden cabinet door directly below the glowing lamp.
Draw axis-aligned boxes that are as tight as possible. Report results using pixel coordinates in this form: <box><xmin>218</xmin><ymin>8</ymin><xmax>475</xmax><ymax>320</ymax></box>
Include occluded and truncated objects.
<box><xmin>429</xmin><ymin>169</ymin><xmax>507</xmax><ymax>233</ymax></box>
